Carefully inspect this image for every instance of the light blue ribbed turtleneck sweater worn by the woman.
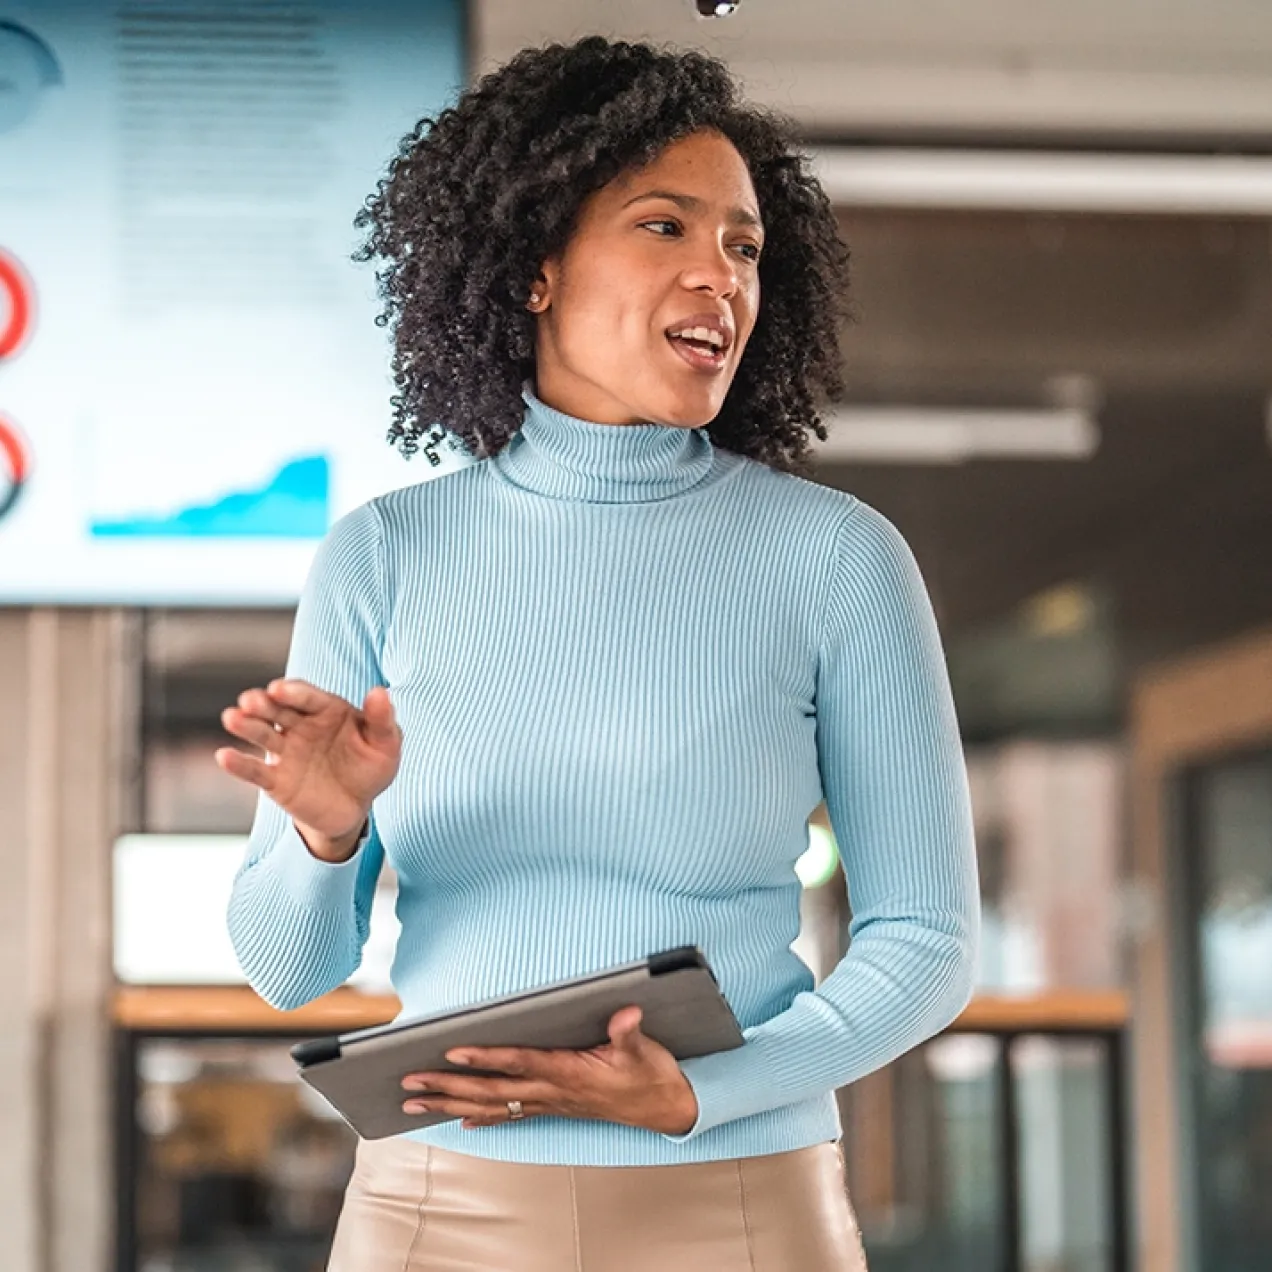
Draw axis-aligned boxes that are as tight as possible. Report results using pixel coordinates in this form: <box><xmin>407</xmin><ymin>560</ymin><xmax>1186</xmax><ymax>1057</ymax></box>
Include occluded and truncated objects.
<box><xmin>229</xmin><ymin>392</ymin><xmax>978</xmax><ymax>1165</ymax></box>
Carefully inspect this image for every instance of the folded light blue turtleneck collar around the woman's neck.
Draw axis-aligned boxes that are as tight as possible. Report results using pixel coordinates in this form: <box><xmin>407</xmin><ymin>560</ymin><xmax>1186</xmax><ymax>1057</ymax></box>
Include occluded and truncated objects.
<box><xmin>490</xmin><ymin>384</ymin><xmax>714</xmax><ymax>504</ymax></box>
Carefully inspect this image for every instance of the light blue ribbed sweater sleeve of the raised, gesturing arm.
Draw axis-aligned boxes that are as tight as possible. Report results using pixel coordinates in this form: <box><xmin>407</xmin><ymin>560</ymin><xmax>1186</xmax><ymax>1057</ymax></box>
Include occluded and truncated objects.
<box><xmin>226</xmin><ymin>505</ymin><xmax>384</xmax><ymax>1010</ymax></box>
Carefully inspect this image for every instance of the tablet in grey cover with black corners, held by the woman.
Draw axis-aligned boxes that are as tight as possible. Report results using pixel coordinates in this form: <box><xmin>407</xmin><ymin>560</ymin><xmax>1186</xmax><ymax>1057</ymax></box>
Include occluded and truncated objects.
<box><xmin>291</xmin><ymin>945</ymin><xmax>743</xmax><ymax>1140</ymax></box>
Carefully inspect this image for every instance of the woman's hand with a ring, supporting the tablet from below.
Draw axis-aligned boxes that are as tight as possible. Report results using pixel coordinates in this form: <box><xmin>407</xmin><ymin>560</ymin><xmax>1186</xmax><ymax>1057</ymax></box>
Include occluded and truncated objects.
<box><xmin>402</xmin><ymin>1007</ymin><xmax>698</xmax><ymax>1135</ymax></box>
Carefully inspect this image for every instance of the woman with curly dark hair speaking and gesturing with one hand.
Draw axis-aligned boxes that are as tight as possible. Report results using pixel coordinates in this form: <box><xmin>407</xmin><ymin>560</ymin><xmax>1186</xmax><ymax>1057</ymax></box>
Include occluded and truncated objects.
<box><xmin>218</xmin><ymin>38</ymin><xmax>978</xmax><ymax>1272</ymax></box>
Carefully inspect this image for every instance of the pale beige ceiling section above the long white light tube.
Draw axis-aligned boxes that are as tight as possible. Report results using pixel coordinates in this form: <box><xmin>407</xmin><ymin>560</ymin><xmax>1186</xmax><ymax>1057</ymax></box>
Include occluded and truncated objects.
<box><xmin>472</xmin><ymin>0</ymin><xmax>1272</xmax><ymax>149</ymax></box>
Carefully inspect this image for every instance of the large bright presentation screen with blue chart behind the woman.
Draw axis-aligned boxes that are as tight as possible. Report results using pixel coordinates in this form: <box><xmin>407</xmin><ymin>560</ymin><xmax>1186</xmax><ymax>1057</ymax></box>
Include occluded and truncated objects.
<box><xmin>0</xmin><ymin>0</ymin><xmax>469</xmax><ymax>605</ymax></box>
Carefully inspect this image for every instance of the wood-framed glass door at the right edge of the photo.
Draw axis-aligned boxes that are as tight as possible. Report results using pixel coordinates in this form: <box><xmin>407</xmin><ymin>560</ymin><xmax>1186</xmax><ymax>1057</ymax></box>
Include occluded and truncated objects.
<box><xmin>1126</xmin><ymin>631</ymin><xmax>1272</xmax><ymax>1272</ymax></box>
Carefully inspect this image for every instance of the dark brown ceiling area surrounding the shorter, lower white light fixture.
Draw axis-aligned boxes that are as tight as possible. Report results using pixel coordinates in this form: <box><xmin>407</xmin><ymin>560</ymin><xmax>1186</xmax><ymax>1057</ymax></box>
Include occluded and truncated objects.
<box><xmin>820</xmin><ymin>212</ymin><xmax>1272</xmax><ymax>686</ymax></box>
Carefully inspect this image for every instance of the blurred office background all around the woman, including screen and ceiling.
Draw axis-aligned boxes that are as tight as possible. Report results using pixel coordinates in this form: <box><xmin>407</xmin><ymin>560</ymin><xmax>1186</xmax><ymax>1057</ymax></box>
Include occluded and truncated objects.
<box><xmin>0</xmin><ymin>0</ymin><xmax>1272</xmax><ymax>1272</ymax></box>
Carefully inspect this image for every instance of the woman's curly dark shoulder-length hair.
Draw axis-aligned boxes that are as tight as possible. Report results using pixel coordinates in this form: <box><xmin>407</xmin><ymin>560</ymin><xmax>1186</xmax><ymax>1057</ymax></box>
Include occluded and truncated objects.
<box><xmin>354</xmin><ymin>36</ymin><xmax>848</xmax><ymax>476</ymax></box>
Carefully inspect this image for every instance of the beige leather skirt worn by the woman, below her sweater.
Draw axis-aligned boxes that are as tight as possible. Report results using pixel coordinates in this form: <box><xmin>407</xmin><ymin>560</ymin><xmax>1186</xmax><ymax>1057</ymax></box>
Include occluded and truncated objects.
<box><xmin>328</xmin><ymin>1138</ymin><xmax>866</xmax><ymax>1272</ymax></box>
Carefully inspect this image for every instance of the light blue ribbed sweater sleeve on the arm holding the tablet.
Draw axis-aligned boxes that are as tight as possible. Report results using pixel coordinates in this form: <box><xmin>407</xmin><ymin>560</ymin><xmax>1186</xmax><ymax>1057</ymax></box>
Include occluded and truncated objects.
<box><xmin>670</xmin><ymin>504</ymin><xmax>979</xmax><ymax>1140</ymax></box>
